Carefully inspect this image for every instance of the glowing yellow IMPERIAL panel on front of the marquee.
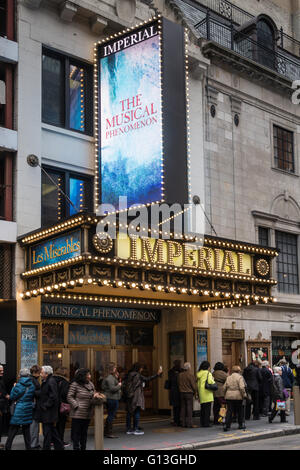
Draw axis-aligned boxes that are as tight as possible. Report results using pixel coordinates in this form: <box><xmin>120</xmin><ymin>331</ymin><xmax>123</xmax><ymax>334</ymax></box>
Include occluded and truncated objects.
<box><xmin>117</xmin><ymin>237</ymin><xmax>252</xmax><ymax>276</ymax></box>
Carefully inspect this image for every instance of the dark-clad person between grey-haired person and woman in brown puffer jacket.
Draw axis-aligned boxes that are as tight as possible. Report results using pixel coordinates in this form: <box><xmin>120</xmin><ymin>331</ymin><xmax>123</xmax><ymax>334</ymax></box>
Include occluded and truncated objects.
<box><xmin>53</xmin><ymin>367</ymin><xmax>71</xmax><ymax>447</ymax></box>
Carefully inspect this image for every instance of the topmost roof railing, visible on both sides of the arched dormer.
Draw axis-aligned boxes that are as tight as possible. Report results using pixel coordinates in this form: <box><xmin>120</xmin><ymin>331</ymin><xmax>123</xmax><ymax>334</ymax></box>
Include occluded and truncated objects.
<box><xmin>192</xmin><ymin>0</ymin><xmax>300</xmax><ymax>57</ymax></box>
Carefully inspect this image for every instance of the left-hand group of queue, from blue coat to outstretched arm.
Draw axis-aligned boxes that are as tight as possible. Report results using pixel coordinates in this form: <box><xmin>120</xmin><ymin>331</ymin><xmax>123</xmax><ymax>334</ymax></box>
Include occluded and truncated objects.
<box><xmin>0</xmin><ymin>363</ymin><xmax>162</xmax><ymax>450</ymax></box>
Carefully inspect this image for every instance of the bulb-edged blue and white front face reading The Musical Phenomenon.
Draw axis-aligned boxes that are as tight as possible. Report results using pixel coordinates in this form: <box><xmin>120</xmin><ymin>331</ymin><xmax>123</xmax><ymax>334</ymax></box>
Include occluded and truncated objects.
<box><xmin>97</xmin><ymin>20</ymin><xmax>163</xmax><ymax>210</ymax></box>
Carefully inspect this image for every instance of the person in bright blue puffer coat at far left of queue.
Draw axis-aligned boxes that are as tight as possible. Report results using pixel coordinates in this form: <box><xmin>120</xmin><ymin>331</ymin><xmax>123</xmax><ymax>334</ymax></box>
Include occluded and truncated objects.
<box><xmin>5</xmin><ymin>369</ymin><xmax>35</xmax><ymax>450</ymax></box>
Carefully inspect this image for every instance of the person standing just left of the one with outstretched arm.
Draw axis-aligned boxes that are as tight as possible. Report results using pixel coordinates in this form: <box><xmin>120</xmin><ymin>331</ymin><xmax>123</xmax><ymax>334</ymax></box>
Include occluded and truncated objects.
<box><xmin>102</xmin><ymin>362</ymin><xmax>122</xmax><ymax>439</ymax></box>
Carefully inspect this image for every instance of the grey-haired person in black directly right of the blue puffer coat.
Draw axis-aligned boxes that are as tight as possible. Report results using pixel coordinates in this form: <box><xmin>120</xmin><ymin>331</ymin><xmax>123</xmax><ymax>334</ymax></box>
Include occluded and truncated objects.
<box><xmin>38</xmin><ymin>366</ymin><xmax>64</xmax><ymax>450</ymax></box>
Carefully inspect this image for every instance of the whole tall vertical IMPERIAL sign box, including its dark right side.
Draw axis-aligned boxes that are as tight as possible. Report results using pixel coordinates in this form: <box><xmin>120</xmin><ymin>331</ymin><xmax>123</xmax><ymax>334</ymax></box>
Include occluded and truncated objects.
<box><xmin>95</xmin><ymin>18</ymin><xmax>187</xmax><ymax>210</ymax></box>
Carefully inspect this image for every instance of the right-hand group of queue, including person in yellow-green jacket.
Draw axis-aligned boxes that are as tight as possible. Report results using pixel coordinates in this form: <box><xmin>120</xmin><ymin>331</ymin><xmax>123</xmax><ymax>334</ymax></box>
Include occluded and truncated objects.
<box><xmin>165</xmin><ymin>359</ymin><xmax>300</xmax><ymax>432</ymax></box>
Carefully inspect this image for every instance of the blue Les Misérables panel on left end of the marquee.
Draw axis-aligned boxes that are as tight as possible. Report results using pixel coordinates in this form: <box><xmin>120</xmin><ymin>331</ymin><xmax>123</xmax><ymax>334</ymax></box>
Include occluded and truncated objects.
<box><xmin>30</xmin><ymin>230</ymin><xmax>81</xmax><ymax>269</ymax></box>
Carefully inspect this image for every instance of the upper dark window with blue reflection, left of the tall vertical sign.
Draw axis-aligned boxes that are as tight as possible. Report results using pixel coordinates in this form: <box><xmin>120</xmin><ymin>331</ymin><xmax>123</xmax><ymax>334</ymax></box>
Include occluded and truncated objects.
<box><xmin>42</xmin><ymin>49</ymin><xmax>92</xmax><ymax>135</ymax></box>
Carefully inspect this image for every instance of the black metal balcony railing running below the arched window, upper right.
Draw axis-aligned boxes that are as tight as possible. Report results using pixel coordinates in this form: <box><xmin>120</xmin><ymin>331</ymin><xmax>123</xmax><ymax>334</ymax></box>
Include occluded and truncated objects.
<box><xmin>195</xmin><ymin>13</ymin><xmax>300</xmax><ymax>81</ymax></box>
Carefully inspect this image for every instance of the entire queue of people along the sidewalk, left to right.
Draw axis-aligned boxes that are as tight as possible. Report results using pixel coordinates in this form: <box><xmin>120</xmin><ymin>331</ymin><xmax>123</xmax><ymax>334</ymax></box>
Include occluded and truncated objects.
<box><xmin>0</xmin><ymin>359</ymin><xmax>300</xmax><ymax>450</ymax></box>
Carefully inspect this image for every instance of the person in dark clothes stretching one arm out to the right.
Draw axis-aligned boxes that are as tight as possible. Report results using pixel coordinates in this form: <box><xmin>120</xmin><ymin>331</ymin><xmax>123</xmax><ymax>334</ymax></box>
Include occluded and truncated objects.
<box><xmin>123</xmin><ymin>362</ymin><xmax>163</xmax><ymax>436</ymax></box>
